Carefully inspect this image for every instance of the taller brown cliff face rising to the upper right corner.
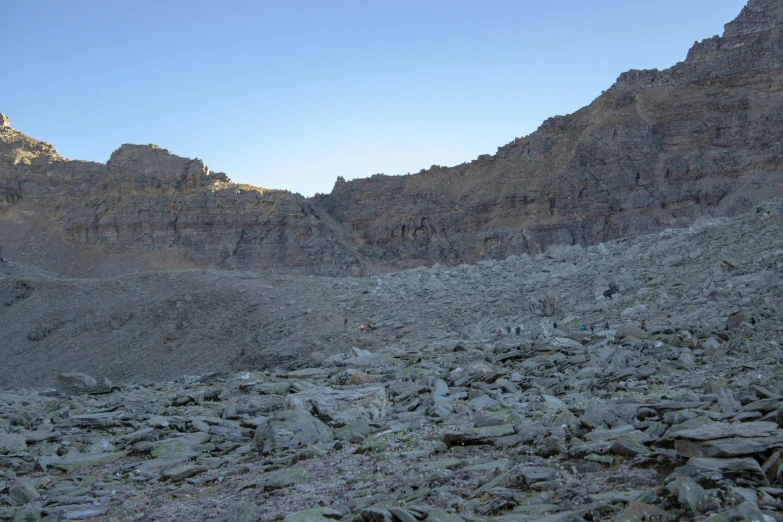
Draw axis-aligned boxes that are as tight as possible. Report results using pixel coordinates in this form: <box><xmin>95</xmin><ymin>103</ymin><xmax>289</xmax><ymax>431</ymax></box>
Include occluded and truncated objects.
<box><xmin>318</xmin><ymin>0</ymin><xmax>783</xmax><ymax>266</ymax></box>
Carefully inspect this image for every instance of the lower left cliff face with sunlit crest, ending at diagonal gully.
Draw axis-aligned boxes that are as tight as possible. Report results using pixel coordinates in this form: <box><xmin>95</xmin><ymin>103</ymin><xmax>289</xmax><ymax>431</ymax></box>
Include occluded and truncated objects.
<box><xmin>0</xmin><ymin>123</ymin><xmax>370</xmax><ymax>275</ymax></box>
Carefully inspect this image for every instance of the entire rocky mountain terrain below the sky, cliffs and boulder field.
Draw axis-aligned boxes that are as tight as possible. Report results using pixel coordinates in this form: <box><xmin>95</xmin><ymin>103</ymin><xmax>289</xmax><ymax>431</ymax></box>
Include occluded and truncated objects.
<box><xmin>0</xmin><ymin>0</ymin><xmax>783</xmax><ymax>522</ymax></box>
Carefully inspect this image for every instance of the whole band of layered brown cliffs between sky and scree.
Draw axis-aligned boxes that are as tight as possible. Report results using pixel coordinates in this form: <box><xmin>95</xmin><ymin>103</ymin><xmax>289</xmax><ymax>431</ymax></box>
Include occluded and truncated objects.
<box><xmin>0</xmin><ymin>0</ymin><xmax>783</xmax><ymax>274</ymax></box>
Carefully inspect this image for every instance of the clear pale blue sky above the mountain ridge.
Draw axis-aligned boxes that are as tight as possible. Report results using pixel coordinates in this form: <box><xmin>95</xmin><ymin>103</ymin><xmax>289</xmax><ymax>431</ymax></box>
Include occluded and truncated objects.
<box><xmin>0</xmin><ymin>0</ymin><xmax>745</xmax><ymax>196</ymax></box>
